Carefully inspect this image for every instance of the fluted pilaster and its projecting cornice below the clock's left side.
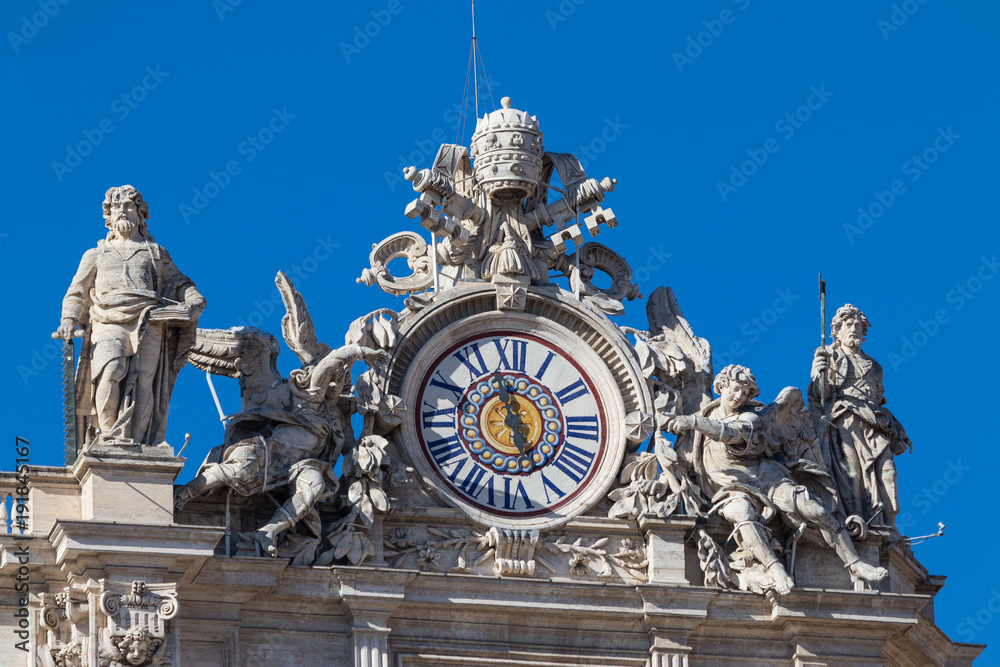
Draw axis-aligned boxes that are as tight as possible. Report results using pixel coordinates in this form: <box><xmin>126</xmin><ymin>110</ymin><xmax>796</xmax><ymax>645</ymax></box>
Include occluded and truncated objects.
<box><xmin>333</xmin><ymin>567</ymin><xmax>416</xmax><ymax>667</ymax></box>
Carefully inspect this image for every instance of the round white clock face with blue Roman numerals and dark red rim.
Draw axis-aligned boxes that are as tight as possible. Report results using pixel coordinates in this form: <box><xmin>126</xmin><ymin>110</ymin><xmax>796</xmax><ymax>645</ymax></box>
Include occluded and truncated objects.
<box><xmin>418</xmin><ymin>331</ymin><xmax>608</xmax><ymax>518</ymax></box>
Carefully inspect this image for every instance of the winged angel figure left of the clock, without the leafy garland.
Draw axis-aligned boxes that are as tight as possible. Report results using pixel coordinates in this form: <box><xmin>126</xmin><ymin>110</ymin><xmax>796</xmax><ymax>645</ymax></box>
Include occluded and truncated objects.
<box><xmin>175</xmin><ymin>272</ymin><xmax>388</xmax><ymax>556</ymax></box>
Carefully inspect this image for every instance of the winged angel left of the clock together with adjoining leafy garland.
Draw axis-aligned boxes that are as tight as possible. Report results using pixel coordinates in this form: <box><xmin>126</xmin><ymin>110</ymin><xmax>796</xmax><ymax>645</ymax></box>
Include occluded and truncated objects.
<box><xmin>174</xmin><ymin>271</ymin><xmax>402</xmax><ymax>565</ymax></box>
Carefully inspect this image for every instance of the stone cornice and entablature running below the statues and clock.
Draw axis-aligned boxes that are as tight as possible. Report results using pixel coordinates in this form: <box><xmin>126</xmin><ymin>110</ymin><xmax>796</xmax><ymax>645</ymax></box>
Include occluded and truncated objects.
<box><xmin>0</xmin><ymin>464</ymin><xmax>983</xmax><ymax>667</ymax></box>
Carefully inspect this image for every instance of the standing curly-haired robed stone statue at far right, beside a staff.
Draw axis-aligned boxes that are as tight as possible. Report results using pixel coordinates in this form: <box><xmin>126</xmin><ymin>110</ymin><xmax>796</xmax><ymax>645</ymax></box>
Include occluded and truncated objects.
<box><xmin>809</xmin><ymin>304</ymin><xmax>912</xmax><ymax>527</ymax></box>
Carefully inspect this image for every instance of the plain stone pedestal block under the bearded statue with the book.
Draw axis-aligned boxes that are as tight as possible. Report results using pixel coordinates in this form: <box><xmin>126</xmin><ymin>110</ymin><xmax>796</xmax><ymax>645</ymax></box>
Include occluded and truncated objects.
<box><xmin>73</xmin><ymin>445</ymin><xmax>184</xmax><ymax>525</ymax></box>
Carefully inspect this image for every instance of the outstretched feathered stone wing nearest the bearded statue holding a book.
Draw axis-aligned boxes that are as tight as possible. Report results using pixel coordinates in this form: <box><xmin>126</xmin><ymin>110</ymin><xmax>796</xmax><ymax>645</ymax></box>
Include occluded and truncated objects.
<box><xmin>188</xmin><ymin>327</ymin><xmax>284</xmax><ymax>410</ymax></box>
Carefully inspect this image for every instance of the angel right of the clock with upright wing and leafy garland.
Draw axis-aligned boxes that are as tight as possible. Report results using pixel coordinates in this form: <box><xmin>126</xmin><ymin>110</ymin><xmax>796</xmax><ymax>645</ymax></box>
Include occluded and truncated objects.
<box><xmin>609</xmin><ymin>287</ymin><xmax>886</xmax><ymax>594</ymax></box>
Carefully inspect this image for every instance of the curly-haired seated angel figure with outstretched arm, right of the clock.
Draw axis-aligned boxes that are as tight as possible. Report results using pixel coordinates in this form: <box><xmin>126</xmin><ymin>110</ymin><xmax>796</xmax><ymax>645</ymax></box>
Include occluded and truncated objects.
<box><xmin>666</xmin><ymin>365</ymin><xmax>887</xmax><ymax>594</ymax></box>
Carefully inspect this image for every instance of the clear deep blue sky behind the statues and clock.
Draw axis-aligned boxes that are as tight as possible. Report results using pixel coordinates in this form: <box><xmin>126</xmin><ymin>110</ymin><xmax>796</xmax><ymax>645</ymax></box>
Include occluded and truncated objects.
<box><xmin>0</xmin><ymin>0</ymin><xmax>1000</xmax><ymax>660</ymax></box>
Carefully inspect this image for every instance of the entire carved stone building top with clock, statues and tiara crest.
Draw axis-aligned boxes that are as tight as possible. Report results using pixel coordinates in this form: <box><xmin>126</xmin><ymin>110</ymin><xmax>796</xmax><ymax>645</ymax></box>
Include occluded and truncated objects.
<box><xmin>0</xmin><ymin>98</ymin><xmax>983</xmax><ymax>667</ymax></box>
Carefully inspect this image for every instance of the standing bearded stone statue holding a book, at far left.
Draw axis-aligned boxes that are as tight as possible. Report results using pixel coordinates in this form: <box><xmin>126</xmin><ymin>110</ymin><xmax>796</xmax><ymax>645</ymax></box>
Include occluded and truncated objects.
<box><xmin>53</xmin><ymin>185</ymin><xmax>205</xmax><ymax>445</ymax></box>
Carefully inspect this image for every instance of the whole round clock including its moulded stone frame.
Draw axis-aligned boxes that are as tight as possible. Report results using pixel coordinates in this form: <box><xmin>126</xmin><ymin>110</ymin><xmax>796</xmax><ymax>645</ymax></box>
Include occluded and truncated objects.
<box><xmin>389</xmin><ymin>285</ymin><xmax>650</xmax><ymax>529</ymax></box>
